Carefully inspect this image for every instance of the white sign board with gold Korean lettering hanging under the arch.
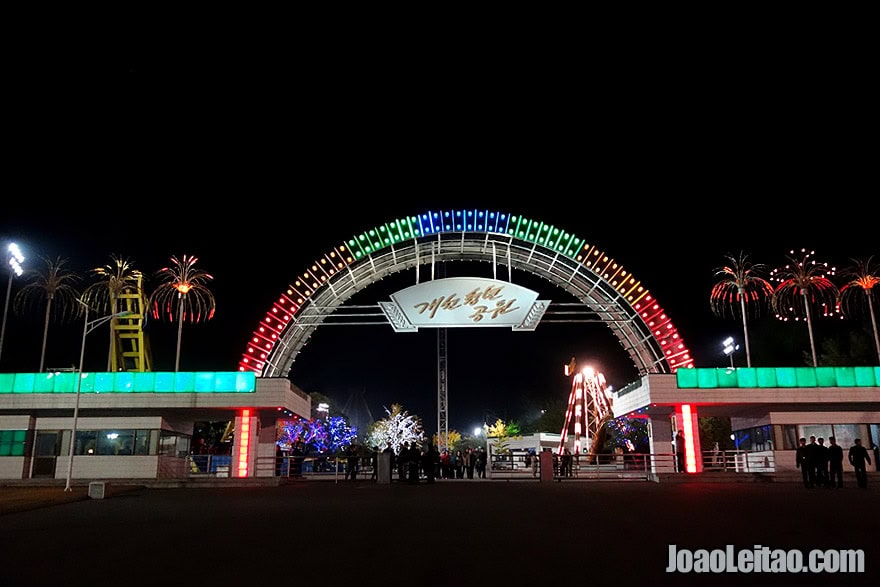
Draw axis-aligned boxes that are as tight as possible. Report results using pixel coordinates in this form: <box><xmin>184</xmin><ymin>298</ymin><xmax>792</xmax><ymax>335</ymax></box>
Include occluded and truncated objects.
<box><xmin>379</xmin><ymin>277</ymin><xmax>550</xmax><ymax>332</ymax></box>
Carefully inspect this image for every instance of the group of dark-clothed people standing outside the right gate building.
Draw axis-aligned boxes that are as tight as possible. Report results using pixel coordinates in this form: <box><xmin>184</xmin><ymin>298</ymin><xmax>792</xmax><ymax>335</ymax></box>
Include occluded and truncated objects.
<box><xmin>795</xmin><ymin>436</ymin><xmax>871</xmax><ymax>489</ymax></box>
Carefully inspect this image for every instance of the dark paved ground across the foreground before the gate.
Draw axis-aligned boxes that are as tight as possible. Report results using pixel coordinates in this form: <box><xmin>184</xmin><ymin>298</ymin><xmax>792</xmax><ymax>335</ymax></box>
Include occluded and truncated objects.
<box><xmin>0</xmin><ymin>481</ymin><xmax>880</xmax><ymax>587</ymax></box>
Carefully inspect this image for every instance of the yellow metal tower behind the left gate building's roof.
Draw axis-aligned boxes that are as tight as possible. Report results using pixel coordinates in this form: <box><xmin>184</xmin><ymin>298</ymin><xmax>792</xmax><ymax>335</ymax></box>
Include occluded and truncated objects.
<box><xmin>110</xmin><ymin>275</ymin><xmax>153</xmax><ymax>372</ymax></box>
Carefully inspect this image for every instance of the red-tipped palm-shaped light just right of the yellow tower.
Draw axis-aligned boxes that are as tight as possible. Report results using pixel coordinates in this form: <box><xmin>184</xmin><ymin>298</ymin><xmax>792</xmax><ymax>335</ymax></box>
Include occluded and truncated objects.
<box><xmin>150</xmin><ymin>255</ymin><xmax>216</xmax><ymax>372</ymax></box>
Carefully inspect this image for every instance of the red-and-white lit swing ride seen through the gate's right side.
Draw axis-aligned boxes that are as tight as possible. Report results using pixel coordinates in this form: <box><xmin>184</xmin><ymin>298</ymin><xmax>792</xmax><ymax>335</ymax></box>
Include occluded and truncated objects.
<box><xmin>558</xmin><ymin>357</ymin><xmax>614</xmax><ymax>462</ymax></box>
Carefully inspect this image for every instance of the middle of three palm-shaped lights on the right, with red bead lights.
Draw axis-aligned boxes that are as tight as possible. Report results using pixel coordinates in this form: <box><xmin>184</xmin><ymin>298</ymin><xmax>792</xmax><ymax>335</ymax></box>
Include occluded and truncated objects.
<box><xmin>771</xmin><ymin>249</ymin><xmax>838</xmax><ymax>367</ymax></box>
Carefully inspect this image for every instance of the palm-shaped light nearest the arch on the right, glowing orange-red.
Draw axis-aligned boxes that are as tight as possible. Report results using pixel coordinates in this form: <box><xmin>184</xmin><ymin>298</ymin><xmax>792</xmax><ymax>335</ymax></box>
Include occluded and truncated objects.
<box><xmin>709</xmin><ymin>252</ymin><xmax>773</xmax><ymax>367</ymax></box>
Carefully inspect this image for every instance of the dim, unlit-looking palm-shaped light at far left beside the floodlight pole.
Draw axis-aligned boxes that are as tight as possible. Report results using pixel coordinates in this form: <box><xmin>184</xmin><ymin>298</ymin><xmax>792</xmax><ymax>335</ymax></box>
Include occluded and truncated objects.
<box><xmin>14</xmin><ymin>257</ymin><xmax>82</xmax><ymax>373</ymax></box>
